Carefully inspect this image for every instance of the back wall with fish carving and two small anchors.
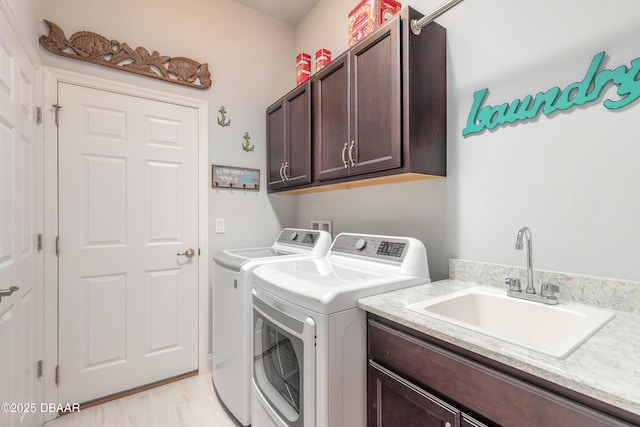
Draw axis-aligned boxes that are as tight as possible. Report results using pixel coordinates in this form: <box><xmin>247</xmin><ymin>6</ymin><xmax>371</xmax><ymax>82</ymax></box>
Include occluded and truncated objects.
<box><xmin>39</xmin><ymin>0</ymin><xmax>295</xmax><ymax>253</ymax></box>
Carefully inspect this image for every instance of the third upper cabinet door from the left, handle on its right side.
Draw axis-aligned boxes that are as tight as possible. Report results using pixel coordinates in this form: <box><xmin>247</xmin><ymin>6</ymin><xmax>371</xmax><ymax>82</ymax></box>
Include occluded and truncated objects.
<box><xmin>314</xmin><ymin>54</ymin><xmax>350</xmax><ymax>181</ymax></box>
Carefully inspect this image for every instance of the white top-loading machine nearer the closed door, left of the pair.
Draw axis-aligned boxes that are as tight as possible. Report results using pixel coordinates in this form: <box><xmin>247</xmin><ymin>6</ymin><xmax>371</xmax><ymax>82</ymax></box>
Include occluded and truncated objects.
<box><xmin>211</xmin><ymin>228</ymin><xmax>331</xmax><ymax>426</ymax></box>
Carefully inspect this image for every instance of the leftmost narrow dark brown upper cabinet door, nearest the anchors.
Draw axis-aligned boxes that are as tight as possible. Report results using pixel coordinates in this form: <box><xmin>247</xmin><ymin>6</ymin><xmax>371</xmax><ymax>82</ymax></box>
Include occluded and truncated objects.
<box><xmin>267</xmin><ymin>101</ymin><xmax>285</xmax><ymax>191</ymax></box>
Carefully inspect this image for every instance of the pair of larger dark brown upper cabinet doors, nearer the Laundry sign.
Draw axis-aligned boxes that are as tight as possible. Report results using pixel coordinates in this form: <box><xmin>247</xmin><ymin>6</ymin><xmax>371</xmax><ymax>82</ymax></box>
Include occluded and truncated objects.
<box><xmin>314</xmin><ymin>15</ymin><xmax>401</xmax><ymax>181</ymax></box>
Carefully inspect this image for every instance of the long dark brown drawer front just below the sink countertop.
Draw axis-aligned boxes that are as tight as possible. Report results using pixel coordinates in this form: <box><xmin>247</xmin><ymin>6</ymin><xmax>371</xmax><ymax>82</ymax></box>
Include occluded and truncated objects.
<box><xmin>368</xmin><ymin>319</ymin><xmax>629</xmax><ymax>427</ymax></box>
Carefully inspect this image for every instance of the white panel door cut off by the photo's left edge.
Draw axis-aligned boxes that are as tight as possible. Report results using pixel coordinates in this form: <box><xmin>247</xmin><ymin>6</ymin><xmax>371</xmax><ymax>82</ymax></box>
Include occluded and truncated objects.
<box><xmin>0</xmin><ymin>6</ymin><xmax>43</xmax><ymax>427</ymax></box>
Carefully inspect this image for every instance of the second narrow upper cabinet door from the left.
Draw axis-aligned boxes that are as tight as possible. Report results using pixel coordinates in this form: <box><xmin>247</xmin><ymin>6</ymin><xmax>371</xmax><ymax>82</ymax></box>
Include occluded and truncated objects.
<box><xmin>284</xmin><ymin>81</ymin><xmax>311</xmax><ymax>187</ymax></box>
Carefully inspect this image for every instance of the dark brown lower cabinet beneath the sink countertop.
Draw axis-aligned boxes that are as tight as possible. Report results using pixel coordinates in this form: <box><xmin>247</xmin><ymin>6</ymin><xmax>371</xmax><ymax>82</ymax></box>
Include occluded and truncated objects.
<box><xmin>368</xmin><ymin>315</ymin><xmax>638</xmax><ymax>427</ymax></box>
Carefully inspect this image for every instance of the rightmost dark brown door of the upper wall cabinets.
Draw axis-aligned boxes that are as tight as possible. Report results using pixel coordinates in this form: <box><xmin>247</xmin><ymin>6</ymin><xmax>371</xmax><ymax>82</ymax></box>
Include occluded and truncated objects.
<box><xmin>348</xmin><ymin>17</ymin><xmax>400</xmax><ymax>175</ymax></box>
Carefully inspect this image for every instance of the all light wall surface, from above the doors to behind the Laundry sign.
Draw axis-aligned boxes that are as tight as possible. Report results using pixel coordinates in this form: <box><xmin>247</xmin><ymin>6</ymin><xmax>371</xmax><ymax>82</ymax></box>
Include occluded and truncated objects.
<box><xmin>32</xmin><ymin>0</ymin><xmax>640</xmax><ymax>280</ymax></box>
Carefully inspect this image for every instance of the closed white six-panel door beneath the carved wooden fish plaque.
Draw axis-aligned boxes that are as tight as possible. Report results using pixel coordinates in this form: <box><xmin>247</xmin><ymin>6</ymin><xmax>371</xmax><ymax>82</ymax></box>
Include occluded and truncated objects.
<box><xmin>58</xmin><ymin>83</ymin><xmax>198</xmax><ymax>403</ymax></box>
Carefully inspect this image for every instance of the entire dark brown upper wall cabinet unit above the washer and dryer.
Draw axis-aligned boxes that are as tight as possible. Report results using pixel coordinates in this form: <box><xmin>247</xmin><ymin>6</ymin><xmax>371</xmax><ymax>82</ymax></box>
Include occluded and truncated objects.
<box><xmin>267</xmin><ymin>7</ymin><xmax>447</xmax><ymax>192</ymax></box>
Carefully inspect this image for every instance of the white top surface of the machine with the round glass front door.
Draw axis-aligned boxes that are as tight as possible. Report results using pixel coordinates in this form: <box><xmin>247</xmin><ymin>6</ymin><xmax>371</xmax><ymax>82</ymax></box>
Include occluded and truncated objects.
<box><xmin>253</xmin><ymin>258</ymin><xmax>429</xmax><ymax>314</ymax></box>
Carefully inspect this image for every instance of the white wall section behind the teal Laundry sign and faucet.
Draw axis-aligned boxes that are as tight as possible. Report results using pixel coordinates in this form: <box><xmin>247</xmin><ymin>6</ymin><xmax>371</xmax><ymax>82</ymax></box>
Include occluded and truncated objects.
<box><xmin>441</xmin><ymin>0</ymin><xmax>640</xmax><ymax>280</ymax></box>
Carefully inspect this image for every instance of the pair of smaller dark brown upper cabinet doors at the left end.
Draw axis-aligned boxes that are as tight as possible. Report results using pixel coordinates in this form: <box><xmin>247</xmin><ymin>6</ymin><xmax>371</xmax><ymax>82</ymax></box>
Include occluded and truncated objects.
<box><xmin>267</xmin><ymin>81</ymin><xmax>311</xmax><ymax>191</ymax></box>
